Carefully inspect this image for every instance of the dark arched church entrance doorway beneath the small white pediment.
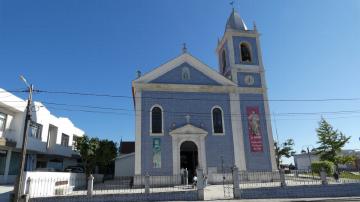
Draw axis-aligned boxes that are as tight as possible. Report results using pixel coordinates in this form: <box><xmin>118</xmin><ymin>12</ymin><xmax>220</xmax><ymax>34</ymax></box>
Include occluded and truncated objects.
<box><xmin>180</xmin><ymin>141</ymin><xmax>199</xmax><ymax>183</ymax></box>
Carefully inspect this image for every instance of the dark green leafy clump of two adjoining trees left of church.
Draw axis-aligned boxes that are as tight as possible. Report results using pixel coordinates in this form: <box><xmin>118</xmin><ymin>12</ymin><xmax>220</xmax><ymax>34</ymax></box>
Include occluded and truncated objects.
<box><xmin>75</xmin><ymin>135</ymin><xmax>117</xmax><ymax>176</ymax></box>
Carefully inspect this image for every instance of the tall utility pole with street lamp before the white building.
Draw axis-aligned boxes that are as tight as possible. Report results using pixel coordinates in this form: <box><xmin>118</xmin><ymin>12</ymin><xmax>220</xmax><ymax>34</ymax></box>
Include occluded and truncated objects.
<box><xmin>14</xmin><ymin>76</ymin><xmax>34</xmax><ymax>202</ymax></box>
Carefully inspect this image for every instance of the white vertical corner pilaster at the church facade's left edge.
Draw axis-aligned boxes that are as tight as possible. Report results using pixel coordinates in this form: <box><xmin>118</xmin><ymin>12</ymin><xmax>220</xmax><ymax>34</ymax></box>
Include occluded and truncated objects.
<box><xmin>134</xmin><ymin>91</ymin><xmax>141</xmax><ymax>175</ymax></box>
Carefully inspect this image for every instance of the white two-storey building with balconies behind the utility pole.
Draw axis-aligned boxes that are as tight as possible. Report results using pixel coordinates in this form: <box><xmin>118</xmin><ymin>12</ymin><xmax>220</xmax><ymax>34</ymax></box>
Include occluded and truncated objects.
<box><xmin>0</xmin><ymin>88</ymin><xmax>84</xmax><ymax>184</ymax></box>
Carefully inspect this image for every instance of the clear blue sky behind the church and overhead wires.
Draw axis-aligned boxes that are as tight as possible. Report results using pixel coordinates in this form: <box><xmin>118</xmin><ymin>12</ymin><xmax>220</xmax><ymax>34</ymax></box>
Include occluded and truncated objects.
<box><xmin>0</xmin><ymin>0</ymin><xmax>360</xmax><ymax>158</ymax></box>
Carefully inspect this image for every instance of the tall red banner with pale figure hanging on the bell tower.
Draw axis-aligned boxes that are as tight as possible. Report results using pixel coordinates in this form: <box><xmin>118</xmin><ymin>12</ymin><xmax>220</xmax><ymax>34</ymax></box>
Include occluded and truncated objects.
<box><xmin>246</xmin><ymin>106</ymin><xmax>263</xmax><ymax>152</ymax></box>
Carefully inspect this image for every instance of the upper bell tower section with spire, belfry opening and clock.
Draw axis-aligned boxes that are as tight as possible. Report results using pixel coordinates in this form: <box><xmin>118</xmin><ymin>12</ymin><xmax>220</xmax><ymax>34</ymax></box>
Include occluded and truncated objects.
<box><xmin>216</xmin><ymin>9</ymin><xmax>263</xmax><ymax>87</ymax></box>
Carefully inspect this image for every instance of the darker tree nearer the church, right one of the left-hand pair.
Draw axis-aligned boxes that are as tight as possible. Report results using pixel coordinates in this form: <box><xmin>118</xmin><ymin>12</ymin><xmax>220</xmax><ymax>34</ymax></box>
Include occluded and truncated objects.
<box><xmin>96</xmin><ymin>139</ymin><xmax>117</xmax><ymax>174</ymax></box>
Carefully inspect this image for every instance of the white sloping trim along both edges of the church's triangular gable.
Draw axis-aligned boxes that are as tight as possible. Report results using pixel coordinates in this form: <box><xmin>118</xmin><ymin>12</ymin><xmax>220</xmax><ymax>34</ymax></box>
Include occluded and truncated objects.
<box><xmin>133</xmin><ymin>53</ymin><xmax>236</xmax><ymax>86</ymax></box>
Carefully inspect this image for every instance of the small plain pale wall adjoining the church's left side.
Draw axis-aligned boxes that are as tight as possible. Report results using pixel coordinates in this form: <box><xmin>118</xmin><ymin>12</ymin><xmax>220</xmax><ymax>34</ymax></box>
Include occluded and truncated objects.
<box><xmin>115</xmin><ymin>153</ymin><xmax>135</xmax><ymax>177</ymax></box>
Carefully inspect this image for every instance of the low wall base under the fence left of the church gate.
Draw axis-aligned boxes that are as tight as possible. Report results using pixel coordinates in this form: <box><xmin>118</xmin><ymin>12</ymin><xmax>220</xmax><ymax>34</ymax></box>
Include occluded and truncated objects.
<box><xmin>29</xmin><ymin>191</ymin><xmax>198</xmax><ymax>202</ymax></box>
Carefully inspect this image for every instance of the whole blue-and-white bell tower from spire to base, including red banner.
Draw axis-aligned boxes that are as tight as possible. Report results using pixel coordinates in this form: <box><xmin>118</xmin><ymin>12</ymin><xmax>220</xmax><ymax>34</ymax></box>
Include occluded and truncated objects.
<box><xmin>216</xmin><ymin>9</ymin><xmax>277</xmax><ymax>171</ymax></box>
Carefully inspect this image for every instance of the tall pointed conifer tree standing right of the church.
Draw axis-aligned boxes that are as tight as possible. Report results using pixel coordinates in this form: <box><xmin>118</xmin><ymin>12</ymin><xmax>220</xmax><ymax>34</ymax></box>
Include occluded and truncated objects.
<box><xmin>316</xmin><ymin>118</ymin><xmax>351</xmax><ymax>169</ymax></box>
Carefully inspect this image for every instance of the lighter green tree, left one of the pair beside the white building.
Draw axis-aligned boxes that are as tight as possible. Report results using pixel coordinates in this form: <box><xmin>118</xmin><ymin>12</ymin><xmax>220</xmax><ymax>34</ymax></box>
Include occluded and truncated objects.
<box><xmin>75</xmin><ymin>135</ymin><xmax>99</xmax><ymax>176</ymax></box>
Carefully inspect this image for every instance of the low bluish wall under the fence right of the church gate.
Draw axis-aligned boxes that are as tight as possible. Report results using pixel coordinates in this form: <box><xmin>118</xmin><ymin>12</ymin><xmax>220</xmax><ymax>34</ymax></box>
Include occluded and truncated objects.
<box><xmin>241</xmin><ymin>183</ymin><xmax>360</xmax><ymax>199</ymax></box>
